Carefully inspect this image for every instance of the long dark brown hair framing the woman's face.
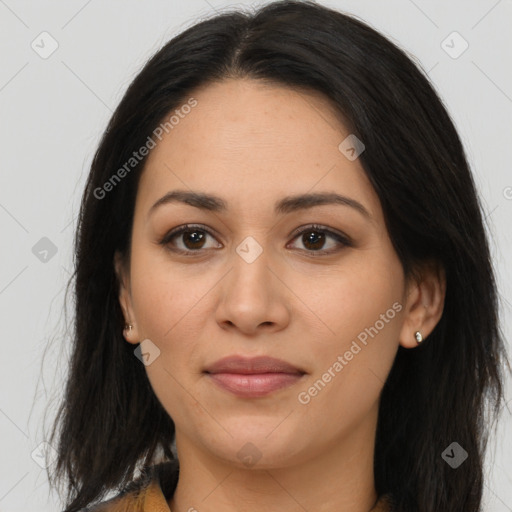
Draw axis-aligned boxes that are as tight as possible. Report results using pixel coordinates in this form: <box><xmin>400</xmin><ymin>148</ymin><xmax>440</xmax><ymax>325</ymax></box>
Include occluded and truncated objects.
<box><xmin>46</xmin><ymin>1</ymin><xmax>510</xmax><ymax>512</ymax></box>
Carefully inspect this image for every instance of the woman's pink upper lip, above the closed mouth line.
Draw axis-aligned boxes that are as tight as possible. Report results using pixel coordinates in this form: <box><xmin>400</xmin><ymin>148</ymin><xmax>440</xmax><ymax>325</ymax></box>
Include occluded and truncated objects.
<box><xmin>205</xmin><ymin>355</ymin><xmax>305</xmax><ymax>374</ymax></box>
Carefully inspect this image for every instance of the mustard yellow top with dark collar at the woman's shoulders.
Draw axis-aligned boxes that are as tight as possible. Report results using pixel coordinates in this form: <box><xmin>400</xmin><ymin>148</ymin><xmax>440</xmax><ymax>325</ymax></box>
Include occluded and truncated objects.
<box><xmin>84</xmin><ymin>461</ymin><xmax>392</xmax><ymax>512</ymax></box>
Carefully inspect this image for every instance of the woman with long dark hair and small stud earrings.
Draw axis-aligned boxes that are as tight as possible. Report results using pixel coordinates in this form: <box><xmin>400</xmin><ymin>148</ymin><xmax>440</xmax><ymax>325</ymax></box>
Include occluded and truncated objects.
<box><xmin>47</xmin><ymin>1</ymin><xmax>510</xmax><ymax>512</ymax></box>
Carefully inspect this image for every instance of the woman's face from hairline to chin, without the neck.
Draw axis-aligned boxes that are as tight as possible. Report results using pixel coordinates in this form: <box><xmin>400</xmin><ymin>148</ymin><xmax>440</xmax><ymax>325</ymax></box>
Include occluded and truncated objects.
<box><xmin>116</xmin><ymin>80</ymin><xmax>428</xmax><ymax>467</ymax></box>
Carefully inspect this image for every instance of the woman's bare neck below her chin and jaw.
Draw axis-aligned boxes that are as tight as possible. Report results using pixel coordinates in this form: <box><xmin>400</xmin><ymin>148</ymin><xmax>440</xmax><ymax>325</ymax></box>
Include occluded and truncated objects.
<box><xmin>169</xmin><ymin>413</ymin><xmax>377</xmax><ymax>512</ymax></box>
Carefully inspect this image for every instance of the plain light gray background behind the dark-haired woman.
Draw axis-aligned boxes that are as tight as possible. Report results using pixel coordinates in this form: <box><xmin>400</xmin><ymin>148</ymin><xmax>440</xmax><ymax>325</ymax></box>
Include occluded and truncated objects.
<box><xmin>0</xmin><ymin>0</ymin><xmax>512</xmax><ymax>512</ymax></box>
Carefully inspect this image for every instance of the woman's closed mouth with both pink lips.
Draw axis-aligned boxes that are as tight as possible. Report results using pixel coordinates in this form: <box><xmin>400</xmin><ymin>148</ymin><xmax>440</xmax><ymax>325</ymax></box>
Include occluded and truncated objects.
<box><xmin>204</xmin><ymin>356</ymin><xmax>306</xmax><ymax>398</ymax></box>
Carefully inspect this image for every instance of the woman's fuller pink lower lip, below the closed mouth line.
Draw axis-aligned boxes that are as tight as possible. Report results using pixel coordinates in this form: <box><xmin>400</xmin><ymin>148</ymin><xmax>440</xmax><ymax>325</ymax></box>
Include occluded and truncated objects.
<box><xmin>207</xmin><ymin>373</ymin><xmax>302</xmax><ymax>398</ymax></box>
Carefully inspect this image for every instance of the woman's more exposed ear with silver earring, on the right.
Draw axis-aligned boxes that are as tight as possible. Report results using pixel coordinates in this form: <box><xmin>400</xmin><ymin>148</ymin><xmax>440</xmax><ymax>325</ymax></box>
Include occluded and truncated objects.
<box><xmin>399</xmin><ymin>262</ymin><xmax>446</xmax><ymax>348</ymax></box>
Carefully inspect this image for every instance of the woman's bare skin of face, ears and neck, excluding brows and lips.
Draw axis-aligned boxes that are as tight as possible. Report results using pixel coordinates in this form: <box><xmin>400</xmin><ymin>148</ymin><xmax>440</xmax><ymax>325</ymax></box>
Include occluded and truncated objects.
<box><xmin>115</xmin><ymin>79</ymin><xmax>445</xmax><ymax>512</ymax></box>
